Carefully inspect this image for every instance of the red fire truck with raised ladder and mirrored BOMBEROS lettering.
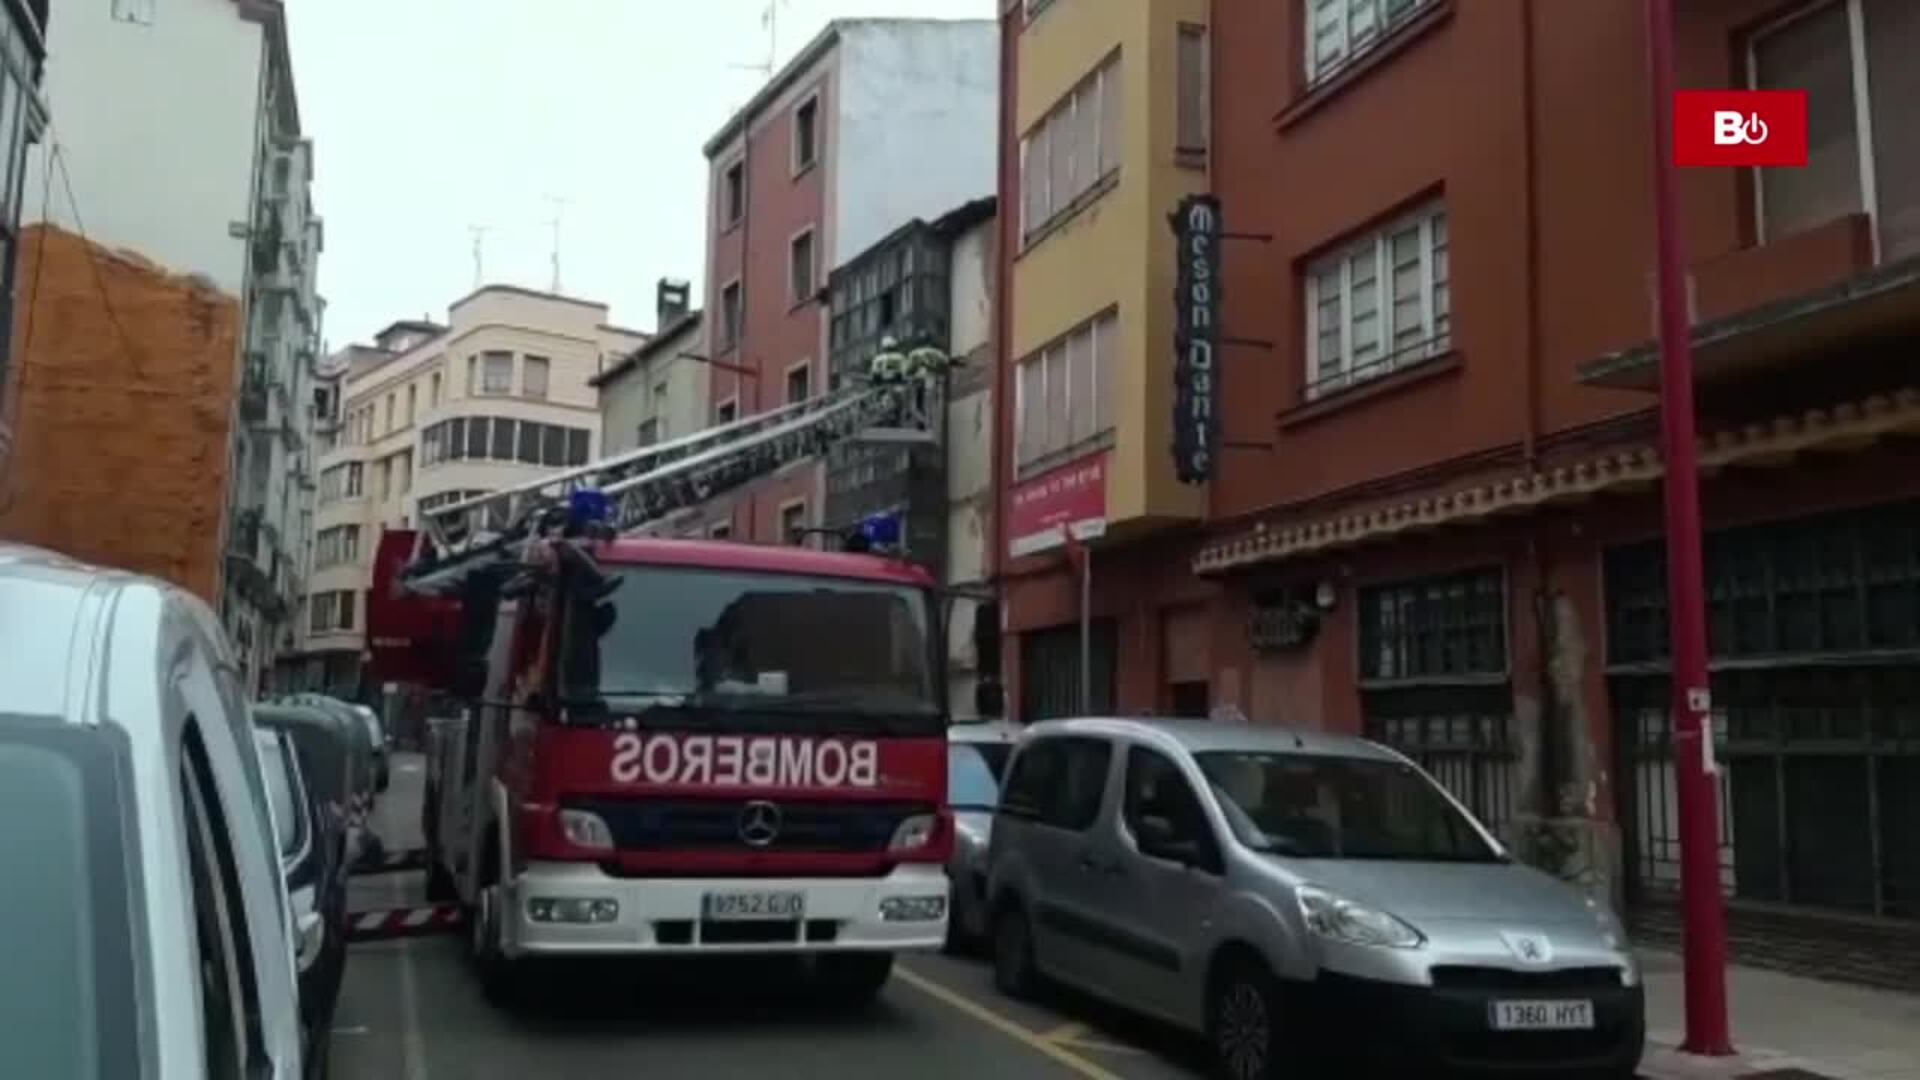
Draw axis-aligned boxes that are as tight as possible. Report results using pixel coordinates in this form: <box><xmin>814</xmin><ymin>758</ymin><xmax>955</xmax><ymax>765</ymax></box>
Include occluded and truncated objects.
<box><xmin>369</xmin><ymin>354</ymin><xmax>996</xmax><ymax>1001</ymax></box>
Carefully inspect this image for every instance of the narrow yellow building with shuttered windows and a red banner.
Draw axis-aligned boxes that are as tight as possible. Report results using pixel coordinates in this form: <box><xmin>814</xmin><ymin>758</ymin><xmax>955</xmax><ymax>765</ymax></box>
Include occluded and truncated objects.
<box><xmin>993</xmin><ymin>0</ymin><xmax>1205</xmax><ymax>721</ymax></box>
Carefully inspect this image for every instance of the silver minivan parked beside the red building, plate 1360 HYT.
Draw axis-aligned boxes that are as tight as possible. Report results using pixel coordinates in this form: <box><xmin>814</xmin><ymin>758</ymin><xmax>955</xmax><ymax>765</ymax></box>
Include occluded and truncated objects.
<box><xmin>989</xmin><ymin>719</ymin><xmax>1645</xmax><ymax>1080</ymax></box>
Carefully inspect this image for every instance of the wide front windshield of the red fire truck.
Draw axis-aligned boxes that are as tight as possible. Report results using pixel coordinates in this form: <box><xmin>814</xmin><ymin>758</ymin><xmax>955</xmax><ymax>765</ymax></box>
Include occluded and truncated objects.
<box><xmin>563</xmin><ymin>567</ymin><xmax>941</xmax><ymax>719</ymax></box>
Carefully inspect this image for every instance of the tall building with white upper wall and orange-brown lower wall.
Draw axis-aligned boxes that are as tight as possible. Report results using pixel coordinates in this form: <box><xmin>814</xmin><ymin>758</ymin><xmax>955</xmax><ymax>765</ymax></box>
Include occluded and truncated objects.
<box><xmin>0</xmin><ymin>0</ymin><xmax>321</xmax><ymax>686</ymax></box>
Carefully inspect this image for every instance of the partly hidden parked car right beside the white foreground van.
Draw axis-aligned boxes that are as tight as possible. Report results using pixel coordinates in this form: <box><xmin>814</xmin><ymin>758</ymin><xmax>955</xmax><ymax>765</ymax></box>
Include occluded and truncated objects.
<box><xmin>253</xmin><ymin>705</ymin><xmax>349</xmax><ymax>1080</ymax></box>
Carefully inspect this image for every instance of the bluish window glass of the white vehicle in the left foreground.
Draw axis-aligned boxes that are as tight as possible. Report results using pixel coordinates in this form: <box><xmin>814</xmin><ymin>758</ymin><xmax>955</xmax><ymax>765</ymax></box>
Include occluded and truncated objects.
<box><xmin>0</xmin><ymin>717</ymin><xmax>142</xmax><ymax>1078</ymax></box>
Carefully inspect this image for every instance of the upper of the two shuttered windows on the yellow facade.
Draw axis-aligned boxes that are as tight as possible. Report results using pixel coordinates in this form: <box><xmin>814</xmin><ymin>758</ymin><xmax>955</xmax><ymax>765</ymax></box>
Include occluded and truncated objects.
<box><xmin>1020</xmin><ymin>52</ymin><xmax>1121</xmax><ymax>240</ymax></box>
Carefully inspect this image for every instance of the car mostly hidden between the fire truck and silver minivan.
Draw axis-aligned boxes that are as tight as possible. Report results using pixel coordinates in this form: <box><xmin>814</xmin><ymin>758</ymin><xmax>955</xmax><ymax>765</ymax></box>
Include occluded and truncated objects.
<box><xmin>947</xmin><ymin>721</ymin><xmax>1021</xmax><ymax>951</ymax></box>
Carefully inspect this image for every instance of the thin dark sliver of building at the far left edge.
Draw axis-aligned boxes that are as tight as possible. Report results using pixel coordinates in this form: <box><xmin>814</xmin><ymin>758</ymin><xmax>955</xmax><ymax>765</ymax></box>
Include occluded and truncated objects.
<box><xmin>0</xmin><ymin>0</ymin><xmax>48</xmax><ymax>482</ymax></box>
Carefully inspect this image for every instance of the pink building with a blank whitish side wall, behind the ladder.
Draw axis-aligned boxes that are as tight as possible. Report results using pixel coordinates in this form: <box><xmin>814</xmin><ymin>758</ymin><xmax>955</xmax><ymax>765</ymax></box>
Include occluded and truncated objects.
<box><xmin>707</xmin><ymin>19</ymin><xmax>995</xmax><ymax>542</ymax></box>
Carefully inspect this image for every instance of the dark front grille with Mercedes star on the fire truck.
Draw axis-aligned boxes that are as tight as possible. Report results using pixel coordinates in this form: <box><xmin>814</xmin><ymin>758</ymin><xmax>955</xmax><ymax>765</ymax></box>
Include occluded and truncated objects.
<box><xmin>563</xmin><ymin>798</ymin><xmax>933</xmax><ymax>853</ymax></box>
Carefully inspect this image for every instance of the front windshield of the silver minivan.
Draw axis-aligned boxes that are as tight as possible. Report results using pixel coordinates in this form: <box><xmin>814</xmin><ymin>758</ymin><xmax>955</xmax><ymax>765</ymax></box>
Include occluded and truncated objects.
<box><xmin>1196</xmin><ymin>751</ymin><xmax>1501</xmax><ymax>863</ymax></box>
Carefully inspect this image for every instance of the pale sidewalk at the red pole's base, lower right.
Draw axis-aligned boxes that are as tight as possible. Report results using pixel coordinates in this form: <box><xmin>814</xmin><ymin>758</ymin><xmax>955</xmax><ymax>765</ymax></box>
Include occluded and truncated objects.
<box><xmin>1640</xmin><ymin>951</ymin><xmax>1920</xmax><ymax>1080</ymax></box>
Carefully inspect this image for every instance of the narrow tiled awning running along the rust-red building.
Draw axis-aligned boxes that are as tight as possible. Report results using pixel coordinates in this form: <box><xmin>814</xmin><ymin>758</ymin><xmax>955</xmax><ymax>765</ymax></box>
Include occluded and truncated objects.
<box><xmin>1194</xmin><ymin>386</ymin><xmax>1920</xmax><ymax>575</ymax></box>
